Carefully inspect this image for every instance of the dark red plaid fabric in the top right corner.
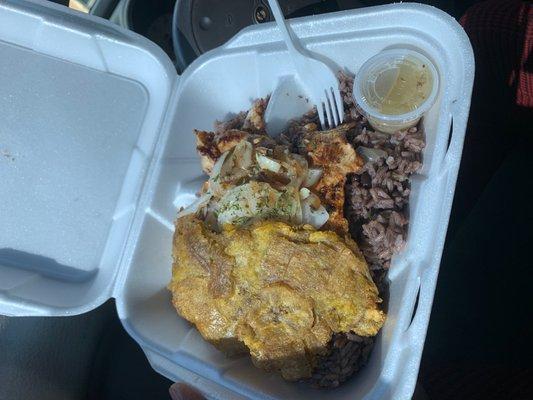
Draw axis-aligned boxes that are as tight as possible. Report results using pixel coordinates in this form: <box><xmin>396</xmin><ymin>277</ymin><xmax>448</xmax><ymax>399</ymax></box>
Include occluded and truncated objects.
<box><xmin>461</xmin><ymin>0</ymin><xmax>533</xmax><ymax>108</ymax></box>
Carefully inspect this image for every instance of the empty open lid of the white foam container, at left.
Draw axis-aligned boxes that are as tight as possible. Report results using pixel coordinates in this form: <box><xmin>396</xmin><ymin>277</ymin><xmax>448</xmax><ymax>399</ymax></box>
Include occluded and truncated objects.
<box><xmin>0</xmin><ymin>1</ymin><xmax>177</xmax><ymax>315</ymax></box>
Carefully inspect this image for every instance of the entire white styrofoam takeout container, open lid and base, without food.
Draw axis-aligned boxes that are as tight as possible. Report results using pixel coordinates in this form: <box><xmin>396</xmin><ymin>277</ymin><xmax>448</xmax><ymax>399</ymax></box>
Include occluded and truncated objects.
<box><xmin>0</xmin><ymin>0</ymin><xmax>474</xmax><ymax>399</ymax></box>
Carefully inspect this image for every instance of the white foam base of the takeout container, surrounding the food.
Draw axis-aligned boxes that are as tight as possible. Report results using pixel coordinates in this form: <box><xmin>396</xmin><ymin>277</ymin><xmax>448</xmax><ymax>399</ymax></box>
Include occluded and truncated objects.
<box><xmin>117</xmin><ymin>4</ymin><xmax>473</xmax><ymax>399</ymax></box>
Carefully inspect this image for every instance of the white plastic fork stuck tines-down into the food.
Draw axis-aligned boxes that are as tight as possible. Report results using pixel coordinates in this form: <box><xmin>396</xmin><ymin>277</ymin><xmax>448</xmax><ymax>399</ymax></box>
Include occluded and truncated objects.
<box><xmin>268</xmin><ymin>0</ymin><xmax>344</xmax><ymax>129</ymax></box>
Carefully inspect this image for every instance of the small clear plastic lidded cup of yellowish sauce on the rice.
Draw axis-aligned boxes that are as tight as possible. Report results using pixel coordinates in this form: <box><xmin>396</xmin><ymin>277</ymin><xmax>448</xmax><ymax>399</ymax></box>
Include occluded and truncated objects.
<box><xmin>353</xmin><ymin>49</ymin><xmax>439</xmax><ymax>133</ymax></box>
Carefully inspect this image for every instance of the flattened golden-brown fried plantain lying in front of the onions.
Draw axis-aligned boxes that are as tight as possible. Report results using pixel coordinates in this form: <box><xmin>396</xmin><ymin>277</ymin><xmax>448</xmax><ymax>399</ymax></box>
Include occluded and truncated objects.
<box><xmin>169</xmin><ymin>215</ymin><xmax>385</xmax><ymax>380</ymax></box>
